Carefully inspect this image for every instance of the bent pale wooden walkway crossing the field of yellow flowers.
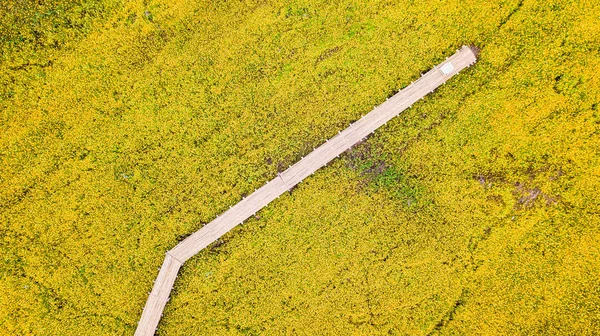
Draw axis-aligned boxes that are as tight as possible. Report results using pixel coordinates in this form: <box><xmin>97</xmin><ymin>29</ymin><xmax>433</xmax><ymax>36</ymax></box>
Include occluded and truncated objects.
<box><xmin>135</xmin><ymin>47</ymin><xmax>477</xmax><ymax>336</ymax></box>
